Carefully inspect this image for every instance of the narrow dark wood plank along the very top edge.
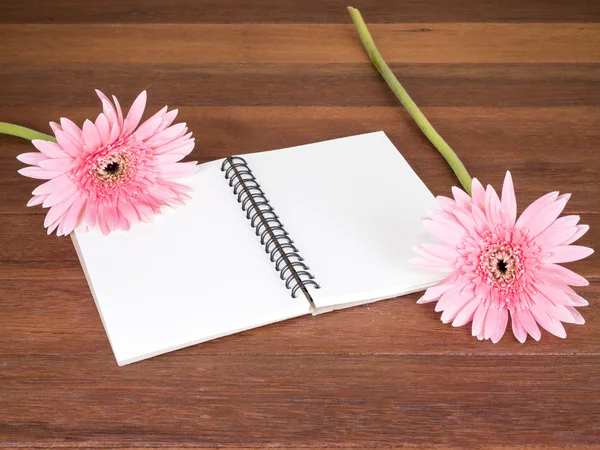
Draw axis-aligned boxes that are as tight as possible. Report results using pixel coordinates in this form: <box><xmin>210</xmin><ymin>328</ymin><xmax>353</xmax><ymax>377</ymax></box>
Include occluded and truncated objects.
<box><xmin>0</xmin><ymin>0</ymin><xmax>600</xmax><ymax>23</ymax></box>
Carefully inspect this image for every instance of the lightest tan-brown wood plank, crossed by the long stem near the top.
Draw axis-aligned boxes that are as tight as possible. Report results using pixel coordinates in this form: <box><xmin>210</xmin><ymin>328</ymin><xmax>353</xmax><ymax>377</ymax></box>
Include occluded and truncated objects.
<box><xmin>0</xmin><ymin>23</ymin><xmax>600</xmax><ymax>65</ymax></box>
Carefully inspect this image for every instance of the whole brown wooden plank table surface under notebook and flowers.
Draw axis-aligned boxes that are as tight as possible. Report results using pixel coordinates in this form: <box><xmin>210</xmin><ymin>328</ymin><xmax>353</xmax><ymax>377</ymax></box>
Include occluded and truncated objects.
<box><xmin>0</xmin><ymin>0</ymin><xmax>600</xmax><ymax>448</ymax></box>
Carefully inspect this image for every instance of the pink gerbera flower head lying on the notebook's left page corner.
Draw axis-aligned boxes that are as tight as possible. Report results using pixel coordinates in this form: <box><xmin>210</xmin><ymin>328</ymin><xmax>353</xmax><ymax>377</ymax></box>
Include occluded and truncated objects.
<box><xmin>17</xmin><ymin>91</ymin><xmax>197</xmax><ymax>236</ymax></box>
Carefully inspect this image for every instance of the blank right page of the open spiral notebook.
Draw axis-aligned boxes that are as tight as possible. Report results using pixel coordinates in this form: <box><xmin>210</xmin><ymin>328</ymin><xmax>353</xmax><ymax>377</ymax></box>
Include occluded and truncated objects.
<box><xmin>243</xmin><ymin>132</ymin><xmax>441</xmax><ymax>312</ymax></box>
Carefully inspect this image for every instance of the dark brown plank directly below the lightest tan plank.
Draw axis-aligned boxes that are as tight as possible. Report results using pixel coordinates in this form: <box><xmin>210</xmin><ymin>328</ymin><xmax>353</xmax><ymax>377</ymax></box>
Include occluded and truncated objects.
<box><xmin>0</xmin><ymin>62</ymin><xmax>600</xmax><ymax>108</ymax></box>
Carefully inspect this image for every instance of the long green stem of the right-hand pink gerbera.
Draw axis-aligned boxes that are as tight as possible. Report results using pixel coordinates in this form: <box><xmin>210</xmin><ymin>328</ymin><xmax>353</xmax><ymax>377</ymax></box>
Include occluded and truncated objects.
<box><xmin>348</xmin><ymin>6</ymin><xmax>471</xmax><ymax>194</ymax></box>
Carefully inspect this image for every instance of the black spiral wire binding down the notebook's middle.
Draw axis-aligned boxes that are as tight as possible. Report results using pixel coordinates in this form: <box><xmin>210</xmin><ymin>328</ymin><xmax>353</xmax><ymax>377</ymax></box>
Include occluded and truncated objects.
<box><xmin>221</xmin><ymin>156</ymin><xmax>321</xmax><ymax>308</ymax></box>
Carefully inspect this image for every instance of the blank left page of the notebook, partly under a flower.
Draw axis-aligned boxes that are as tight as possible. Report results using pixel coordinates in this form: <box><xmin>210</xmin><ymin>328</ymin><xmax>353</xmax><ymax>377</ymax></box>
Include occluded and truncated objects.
<box><xmin>72</xmin><ymin>161</ymin><xmax>310</xmax><ymax>365</ymax></box>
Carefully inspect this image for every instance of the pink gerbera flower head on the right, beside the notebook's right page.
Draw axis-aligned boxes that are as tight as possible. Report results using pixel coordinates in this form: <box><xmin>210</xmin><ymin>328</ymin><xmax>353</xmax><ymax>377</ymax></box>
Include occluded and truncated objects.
<box><xmin>413</xmin><ymin>172</ymin><xmax>593</xmax><ymax>343</ymax></box>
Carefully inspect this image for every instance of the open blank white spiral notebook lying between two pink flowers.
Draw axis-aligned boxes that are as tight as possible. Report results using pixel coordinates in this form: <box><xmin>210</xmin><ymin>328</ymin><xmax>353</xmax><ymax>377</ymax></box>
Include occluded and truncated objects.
<box><xmin>71</xmin><ymin>132</ymin><xmax>441</xmax><ymax>365</ymax></box>
